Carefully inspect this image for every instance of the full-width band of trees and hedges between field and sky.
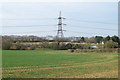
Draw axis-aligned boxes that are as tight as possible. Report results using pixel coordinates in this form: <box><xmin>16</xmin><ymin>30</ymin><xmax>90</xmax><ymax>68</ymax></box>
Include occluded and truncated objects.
<box><xmin>2</xmin><ymin>36</ymin><xmax>120</xmax><ymax>50</ymax></box>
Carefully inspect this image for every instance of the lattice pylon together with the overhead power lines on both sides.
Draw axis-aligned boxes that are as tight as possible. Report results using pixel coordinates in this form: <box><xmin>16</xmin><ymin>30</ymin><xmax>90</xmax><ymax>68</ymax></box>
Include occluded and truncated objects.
<box><xmin>1</xmin><ymin>12</ymin><xmax>116</xmax><ymax>37</ymax></box>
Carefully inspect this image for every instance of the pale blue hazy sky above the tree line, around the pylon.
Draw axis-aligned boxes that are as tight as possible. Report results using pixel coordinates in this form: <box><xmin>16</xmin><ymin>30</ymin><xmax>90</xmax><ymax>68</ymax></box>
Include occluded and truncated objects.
<box><xmin>0</xmin><ymin>2</ymin><xmax>118</xmax><ymax>37</ymax></box>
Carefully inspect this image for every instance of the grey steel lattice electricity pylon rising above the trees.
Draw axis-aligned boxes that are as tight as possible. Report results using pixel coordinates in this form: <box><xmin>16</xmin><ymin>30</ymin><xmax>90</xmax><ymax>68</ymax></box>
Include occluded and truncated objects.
<box><xmin>57</xmin><ymin>11</ymin><xmax>66</xmax><ymax>38</ymax></box>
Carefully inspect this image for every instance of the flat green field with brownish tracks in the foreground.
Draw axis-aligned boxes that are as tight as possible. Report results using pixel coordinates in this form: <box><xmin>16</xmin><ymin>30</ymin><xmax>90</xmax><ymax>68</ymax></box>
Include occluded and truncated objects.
<box><xmin>2</xmin><ymin>50</ymin><xmax>118</xmax><ymax>78</ymax></box>
